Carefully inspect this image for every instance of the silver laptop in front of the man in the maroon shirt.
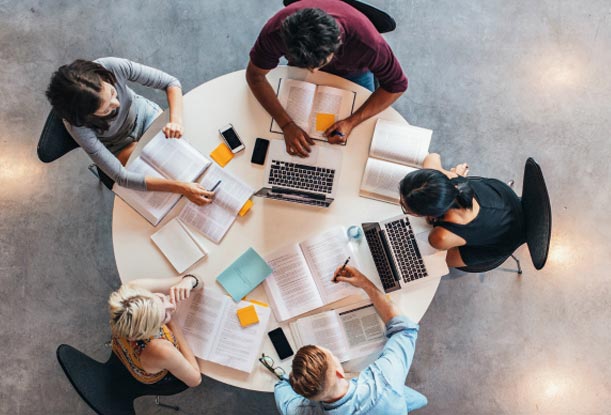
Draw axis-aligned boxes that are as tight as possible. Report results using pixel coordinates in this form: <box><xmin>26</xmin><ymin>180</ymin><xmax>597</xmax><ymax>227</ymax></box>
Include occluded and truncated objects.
<box><xmin>255</xmin><ymin>140</ymin><xmax>342</xmax><ymax>207</ymax></box>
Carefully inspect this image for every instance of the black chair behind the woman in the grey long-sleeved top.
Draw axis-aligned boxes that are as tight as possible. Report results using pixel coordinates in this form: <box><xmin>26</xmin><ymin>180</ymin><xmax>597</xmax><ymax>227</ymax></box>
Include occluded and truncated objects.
<box><xmin>36</xmin><ymin>110</ymin><xmax>114</xmax><ymax>189</ymax></box>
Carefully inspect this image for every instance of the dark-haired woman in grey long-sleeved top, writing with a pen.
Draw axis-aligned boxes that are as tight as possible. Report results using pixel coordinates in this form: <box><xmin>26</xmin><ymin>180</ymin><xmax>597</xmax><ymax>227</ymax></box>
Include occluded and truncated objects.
<box><xmin>46</xmin><ymin>58</ymin><xmax>214</xmax><ymax>205</ymax></box>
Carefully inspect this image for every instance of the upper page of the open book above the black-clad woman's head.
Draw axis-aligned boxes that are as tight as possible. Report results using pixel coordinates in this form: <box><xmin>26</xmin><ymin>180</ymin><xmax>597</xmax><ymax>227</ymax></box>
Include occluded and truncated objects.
<box><xmin>369</xmin><ymin>119</ymin><xmax>433</xmax><ymax>167</ymax></box>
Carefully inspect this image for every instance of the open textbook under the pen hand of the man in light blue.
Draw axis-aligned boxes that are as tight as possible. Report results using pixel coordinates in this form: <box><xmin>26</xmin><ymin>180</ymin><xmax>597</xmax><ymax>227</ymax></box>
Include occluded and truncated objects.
<box><xmin>263</xmin><ymin>227</ymin><xmax>363</xmax><ymax>321</ymax></box>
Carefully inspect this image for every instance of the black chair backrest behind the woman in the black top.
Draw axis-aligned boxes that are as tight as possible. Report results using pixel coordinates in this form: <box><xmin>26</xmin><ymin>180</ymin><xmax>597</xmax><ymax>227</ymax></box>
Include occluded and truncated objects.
<box><xmin>522</xmin><ymin>157</ymin><xmax>552</xmax><ymax>269</ymax></box>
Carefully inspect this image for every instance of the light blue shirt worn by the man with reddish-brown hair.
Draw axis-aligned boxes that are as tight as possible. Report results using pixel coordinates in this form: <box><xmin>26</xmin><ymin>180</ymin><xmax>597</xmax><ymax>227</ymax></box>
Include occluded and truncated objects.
<box><xmin>274</xmin><ymin>316</ymin><xmax>427</xmax><ymax>415</ymax></box>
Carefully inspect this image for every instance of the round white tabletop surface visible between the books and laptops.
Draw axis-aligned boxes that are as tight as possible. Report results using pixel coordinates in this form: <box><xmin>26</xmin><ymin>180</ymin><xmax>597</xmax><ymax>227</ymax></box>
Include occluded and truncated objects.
<box><xmin>112</xmin><ymin>67</ymin><xmax>440</xmax><ymax>391</ymax></box>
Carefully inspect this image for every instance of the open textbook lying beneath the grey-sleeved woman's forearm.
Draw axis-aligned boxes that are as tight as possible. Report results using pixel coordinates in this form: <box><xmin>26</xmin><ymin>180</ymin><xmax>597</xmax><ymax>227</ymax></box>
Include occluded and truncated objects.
<box><xmin>112</xmin><ymin>131</ymin><xmax>211</xmax><ymax>226</ymax></box>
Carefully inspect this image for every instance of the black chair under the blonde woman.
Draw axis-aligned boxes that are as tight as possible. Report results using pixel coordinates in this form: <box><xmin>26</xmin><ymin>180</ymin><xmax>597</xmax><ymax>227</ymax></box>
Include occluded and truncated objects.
<box><xmin>57</xmin><ymin>344</ymin><xmax>188</xmax><ymax>415</ymax></box>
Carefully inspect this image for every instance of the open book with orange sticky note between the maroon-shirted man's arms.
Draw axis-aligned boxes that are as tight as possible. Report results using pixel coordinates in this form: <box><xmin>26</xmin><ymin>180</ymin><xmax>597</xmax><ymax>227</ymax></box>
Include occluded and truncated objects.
<box><xmin>270</xmin><ymin>78</ymin><xmax>356</xmax><ymax>141</ymax></box>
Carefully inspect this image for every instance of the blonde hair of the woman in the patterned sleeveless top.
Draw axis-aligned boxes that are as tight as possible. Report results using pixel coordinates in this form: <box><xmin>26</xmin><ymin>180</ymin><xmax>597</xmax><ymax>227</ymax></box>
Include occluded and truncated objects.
<box><xmin>108</xmin><ymin>285</ymin><xmax>164</xmax><ymax>340</ymax></box>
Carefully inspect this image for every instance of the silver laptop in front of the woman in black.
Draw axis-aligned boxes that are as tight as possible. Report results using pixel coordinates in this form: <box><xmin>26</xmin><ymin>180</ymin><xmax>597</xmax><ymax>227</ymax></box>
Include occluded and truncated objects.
<box><xmin>362</xmin><ymin>215</ymin><xmax>449</xmax><ymax>293</ymax></box>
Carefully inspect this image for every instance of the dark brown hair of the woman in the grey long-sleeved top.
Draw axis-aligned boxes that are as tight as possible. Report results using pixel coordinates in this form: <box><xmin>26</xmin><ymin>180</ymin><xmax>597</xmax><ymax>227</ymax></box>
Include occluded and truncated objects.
<box><xmin>46</xmin><ymin>59</ymin><xmax>117</xmax><ymax>131</ymax></box>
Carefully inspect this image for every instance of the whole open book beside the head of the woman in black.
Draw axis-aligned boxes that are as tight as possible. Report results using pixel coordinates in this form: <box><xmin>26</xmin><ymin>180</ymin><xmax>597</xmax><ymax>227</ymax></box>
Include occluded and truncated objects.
<box><xmin>359</xmin><ymin>119</ymin><xmax>433</xmax><ymax>204</ymax></box>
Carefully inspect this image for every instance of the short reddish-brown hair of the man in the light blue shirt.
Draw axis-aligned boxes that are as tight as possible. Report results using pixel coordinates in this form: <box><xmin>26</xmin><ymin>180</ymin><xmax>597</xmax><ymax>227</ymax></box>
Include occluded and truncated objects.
<box><xmin>289</xmin><ymin>345</ymin><xmax>329</xmax><ymax>399</ymax></box>
